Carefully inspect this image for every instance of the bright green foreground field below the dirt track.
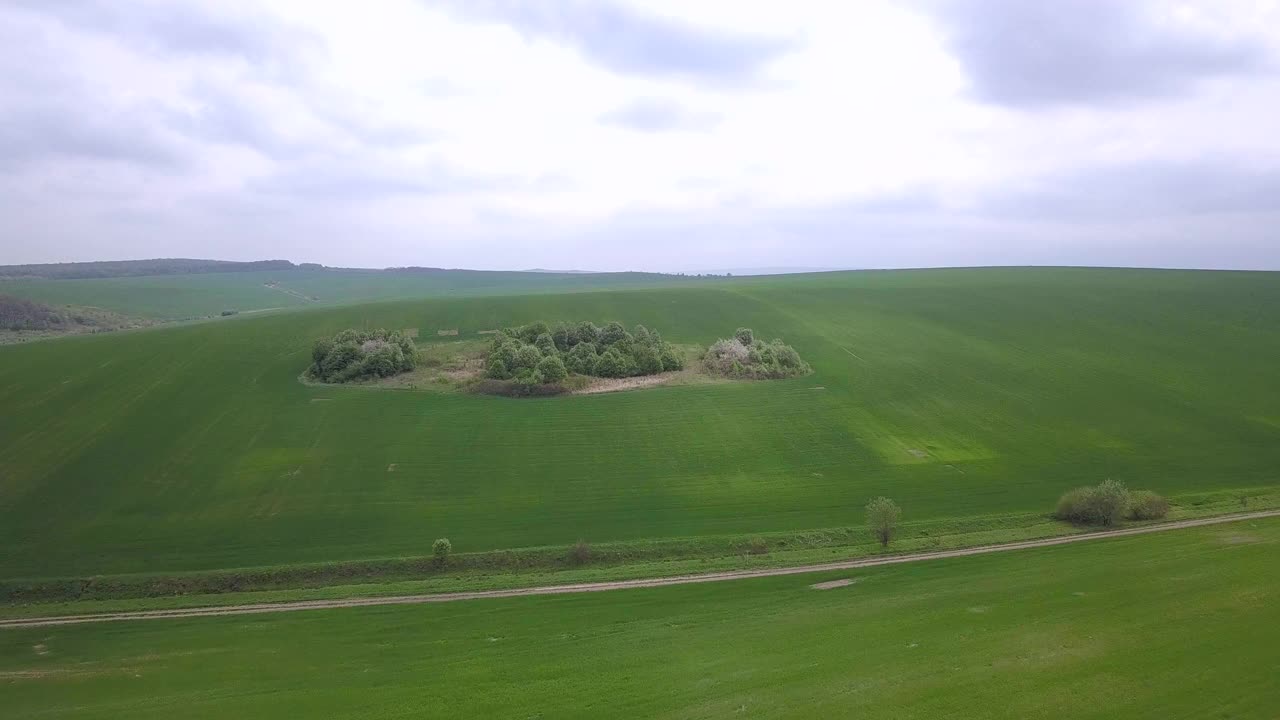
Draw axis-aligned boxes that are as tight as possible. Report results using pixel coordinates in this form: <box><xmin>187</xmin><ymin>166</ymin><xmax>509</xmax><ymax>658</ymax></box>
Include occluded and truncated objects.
<box><xmin>0</xmin><ymin>512</ymin><xmax>1280</xmax><ymax>720</ymax></box>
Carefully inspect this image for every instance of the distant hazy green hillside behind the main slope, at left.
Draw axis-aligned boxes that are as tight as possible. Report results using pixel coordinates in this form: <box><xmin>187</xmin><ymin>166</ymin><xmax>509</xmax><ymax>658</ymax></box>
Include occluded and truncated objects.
<box><xmin>0</xmin><ymin>268</ymin><xmax>695</xmax><ymax>320</ymax></box>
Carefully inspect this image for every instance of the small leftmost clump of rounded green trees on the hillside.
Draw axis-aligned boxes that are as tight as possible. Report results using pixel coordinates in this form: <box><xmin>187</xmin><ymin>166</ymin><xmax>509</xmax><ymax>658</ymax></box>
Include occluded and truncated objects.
<box><xmin>308</xmin><ymin>329</ymin><xmax>417</xmax><ymax>383</ymax></box>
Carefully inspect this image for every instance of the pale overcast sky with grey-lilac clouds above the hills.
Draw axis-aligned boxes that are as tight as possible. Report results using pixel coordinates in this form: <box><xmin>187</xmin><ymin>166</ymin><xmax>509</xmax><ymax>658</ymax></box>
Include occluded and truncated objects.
<box><xmin>0</xmin><ymin>0</ymin><xmax>1280</xmax><ymax>272</ymax></box>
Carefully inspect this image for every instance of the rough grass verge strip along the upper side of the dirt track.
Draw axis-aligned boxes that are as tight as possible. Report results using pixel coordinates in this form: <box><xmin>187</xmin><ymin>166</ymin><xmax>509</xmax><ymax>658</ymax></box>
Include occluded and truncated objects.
<box><xmin>0</xmin><ymin>489</ymin><xmax>1280</xmax><ymax>618</ymax></box>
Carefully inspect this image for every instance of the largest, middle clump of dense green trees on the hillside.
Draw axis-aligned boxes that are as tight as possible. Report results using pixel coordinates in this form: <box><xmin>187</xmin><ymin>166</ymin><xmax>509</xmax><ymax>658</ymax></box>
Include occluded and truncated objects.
<box><xmin>485</xmin><ymin>322</ymin><xmax>685</xmax><ymax>387</ymax></box>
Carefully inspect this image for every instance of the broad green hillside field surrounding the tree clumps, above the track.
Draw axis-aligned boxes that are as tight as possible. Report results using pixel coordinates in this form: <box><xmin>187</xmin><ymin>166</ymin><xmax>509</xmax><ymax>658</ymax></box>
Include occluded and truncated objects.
<box><xmin>0</xmin><ymin>269</ymin><xmax>1280</xmax><ymax>578</ymax></box>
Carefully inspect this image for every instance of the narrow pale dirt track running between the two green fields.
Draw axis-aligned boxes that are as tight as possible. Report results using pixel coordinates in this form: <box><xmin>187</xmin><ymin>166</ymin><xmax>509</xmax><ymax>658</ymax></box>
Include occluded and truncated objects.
<box><xmin>0</xmin><ymin>510</ymin><xmax>1280</xmax><ymax>629</ymax></box>
